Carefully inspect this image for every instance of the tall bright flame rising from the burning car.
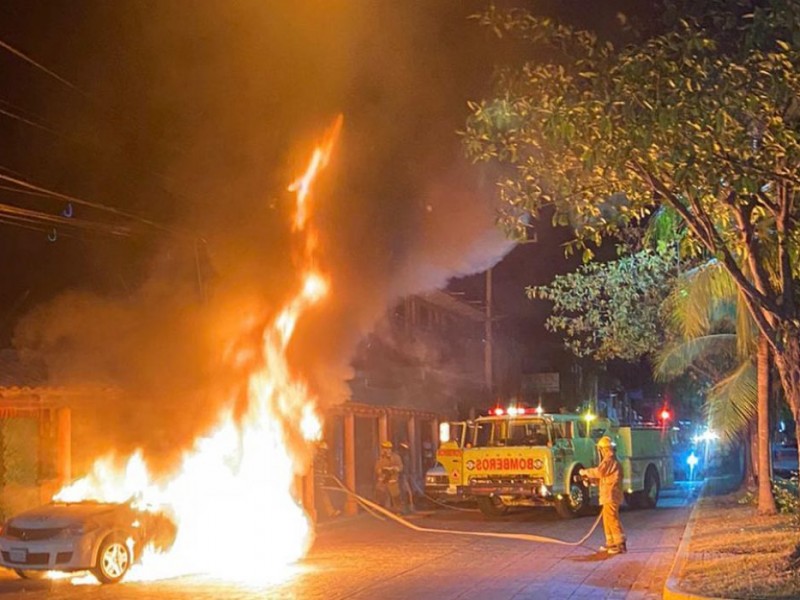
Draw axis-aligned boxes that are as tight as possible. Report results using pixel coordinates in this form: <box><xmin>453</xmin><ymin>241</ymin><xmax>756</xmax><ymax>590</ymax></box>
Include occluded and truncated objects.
<box><xmin>54</xmin><ymin>116</ymin><xmax>342</xmax><ymax>582</ymax></box>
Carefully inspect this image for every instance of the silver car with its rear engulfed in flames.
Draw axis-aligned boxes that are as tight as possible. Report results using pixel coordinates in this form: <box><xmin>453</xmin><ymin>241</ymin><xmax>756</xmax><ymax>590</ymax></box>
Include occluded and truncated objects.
<box><xmin>0</xmin><ymin>501</ymin><xmax>177</xmax><ymax>583</ymax></box>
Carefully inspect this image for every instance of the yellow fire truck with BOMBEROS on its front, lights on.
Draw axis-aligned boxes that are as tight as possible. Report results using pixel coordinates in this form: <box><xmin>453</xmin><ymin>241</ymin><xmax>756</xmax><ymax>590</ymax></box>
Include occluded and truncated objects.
<box><xmin>426</xmin><ymin>407</ymin><xmax>673</xmax><ymax>518</ymax></box>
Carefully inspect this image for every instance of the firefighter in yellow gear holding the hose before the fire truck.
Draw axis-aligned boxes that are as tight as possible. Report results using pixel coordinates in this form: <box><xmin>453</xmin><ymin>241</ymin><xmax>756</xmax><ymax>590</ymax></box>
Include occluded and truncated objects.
<box><xmin>580</xmin><ymin>435</ymin><xmax>628</xmax><ymax>554</ymax></box>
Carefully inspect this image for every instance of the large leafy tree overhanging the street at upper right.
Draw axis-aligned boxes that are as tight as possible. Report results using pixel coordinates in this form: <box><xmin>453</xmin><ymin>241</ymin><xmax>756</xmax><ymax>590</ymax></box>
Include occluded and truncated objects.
<box><xmin>465</xmin><ymin>0</ymin><xmax>800</xmax><ymax>476</ymax></box>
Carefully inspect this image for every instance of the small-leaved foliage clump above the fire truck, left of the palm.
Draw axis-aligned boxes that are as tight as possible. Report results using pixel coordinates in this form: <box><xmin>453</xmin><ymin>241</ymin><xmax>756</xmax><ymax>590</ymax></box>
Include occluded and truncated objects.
<box><xmin>526</xmin><ymin>247</ymin><xmax>677</xmax><ymax>361</ymax></box>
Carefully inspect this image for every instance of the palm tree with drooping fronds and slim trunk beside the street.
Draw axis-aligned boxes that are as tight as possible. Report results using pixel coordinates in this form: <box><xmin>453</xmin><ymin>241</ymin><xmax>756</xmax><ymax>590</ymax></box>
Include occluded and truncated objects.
<box><xmin>655</xmin><ymin>260</ymin><xmax>776</xmax><ymax>514</ymax></box>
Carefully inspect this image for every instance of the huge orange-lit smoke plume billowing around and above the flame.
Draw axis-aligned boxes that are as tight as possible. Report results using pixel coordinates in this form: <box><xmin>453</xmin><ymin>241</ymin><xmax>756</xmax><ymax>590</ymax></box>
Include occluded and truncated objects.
<box><xmin>9</xmin><ymin>0</ymin><xmax>510</xmax><ymax>472</ymax></box>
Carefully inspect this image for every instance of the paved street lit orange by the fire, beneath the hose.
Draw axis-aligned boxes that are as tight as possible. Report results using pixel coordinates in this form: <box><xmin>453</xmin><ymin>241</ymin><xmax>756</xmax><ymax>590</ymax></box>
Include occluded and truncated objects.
<box><xmin>0</xmin><ymin>490</ymin><xmax>693</xmax><ymax>600</ymax></box>
